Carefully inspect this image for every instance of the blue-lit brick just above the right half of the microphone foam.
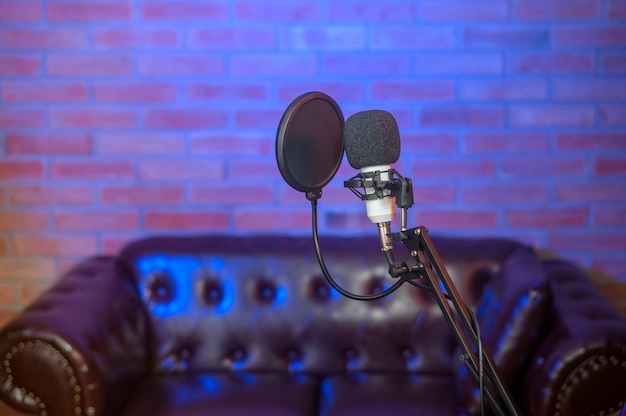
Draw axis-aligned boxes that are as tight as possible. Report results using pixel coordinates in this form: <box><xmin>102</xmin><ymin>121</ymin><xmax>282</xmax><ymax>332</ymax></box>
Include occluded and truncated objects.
<box><xmin>370</xmin><ymin>79</ymin><xmax>455</xmax><ymax>101</ymax></box>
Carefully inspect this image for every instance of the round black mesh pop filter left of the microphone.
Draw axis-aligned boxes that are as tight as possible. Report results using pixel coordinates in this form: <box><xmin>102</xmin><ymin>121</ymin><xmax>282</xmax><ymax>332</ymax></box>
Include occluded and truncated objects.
<box><xmin>276</xmin><ymin>91</ymin><xmax>344</xmax><ymax>196</ymax></box>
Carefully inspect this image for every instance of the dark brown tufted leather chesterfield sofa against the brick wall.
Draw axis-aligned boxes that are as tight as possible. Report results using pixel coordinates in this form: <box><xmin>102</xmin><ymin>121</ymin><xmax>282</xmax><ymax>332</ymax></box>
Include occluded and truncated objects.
<box><xmin>0</xmin><ymin>232</ymin><xmax>626</xmax><ymax>416</ymax></box>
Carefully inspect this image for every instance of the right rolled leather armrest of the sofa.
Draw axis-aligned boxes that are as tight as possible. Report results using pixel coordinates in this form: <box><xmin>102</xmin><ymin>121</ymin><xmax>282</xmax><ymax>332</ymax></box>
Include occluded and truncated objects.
<box><xmin>521</xmin><ymin>260</ymin><xmax>626</xmax><ymax>416</ymax></box>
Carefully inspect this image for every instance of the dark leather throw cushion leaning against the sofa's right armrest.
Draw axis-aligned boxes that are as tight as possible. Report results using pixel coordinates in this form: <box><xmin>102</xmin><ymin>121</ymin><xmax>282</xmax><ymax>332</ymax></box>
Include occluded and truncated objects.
<box><xmin>455</xmin><ymin>247</ymin><xmax>550</xmax><ymax>414</ymax></box>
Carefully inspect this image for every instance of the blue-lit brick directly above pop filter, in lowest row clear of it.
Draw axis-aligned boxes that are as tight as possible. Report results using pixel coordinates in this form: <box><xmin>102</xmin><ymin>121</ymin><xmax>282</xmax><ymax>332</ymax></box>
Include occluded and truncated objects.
<box><xmin>230</xmin><ymin>53</ymin><xmax>317</xmax><ymax>78</ymax></box>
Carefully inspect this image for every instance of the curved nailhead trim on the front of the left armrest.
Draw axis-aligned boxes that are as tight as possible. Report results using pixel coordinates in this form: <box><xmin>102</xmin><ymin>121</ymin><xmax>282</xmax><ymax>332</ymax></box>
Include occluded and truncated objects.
<box><xmin>2</xmin><ymin>339</ymin><xmax>83</xmax><ymax>416</ymax></box>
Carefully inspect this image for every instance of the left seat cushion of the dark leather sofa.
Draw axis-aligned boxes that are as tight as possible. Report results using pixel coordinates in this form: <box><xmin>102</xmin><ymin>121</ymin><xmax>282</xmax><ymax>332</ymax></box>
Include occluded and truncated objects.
<box><xmin>122</xmin><ymin>372</ymin><xmax>319</xmax><ymax>416</ymax></box>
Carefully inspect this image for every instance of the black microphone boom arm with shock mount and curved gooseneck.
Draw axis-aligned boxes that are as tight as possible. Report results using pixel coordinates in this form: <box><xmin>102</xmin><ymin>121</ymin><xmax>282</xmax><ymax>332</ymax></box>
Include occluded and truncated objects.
<box><xmin>306</xmin><ymin>169</ymin><xmax>521</xmax><ymax>416</ymax></box>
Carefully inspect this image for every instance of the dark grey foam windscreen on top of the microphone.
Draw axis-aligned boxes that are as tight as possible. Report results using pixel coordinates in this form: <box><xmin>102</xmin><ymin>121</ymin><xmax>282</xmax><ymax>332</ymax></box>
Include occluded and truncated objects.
<box><xmin>343</xmin><ymin>110</ymin><xmax>400</xmax><ymax>169</ymax></box>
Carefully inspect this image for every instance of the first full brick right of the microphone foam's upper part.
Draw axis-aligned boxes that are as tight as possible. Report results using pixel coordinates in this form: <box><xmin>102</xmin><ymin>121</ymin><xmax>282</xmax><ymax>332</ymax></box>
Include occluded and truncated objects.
<box><xmin>420</xmin><ymin>105</ymin><xmax>504</xmax><ymax>127</ymax></box>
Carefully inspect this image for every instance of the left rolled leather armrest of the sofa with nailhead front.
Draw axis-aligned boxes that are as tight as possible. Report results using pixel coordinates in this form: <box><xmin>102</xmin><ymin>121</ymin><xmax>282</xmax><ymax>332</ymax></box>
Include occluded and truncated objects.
<box><xmin>0</xmin><ymin>257</ymin><xmax>147</xmax><ymax>416</ymax></box>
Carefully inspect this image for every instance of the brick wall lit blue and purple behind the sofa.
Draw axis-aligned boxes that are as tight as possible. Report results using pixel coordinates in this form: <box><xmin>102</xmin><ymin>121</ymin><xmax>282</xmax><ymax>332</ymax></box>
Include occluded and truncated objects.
<box><xmin>0</xmin><ymin>0</ymin><xmax>626</xmax><ymax>320</ymax></box>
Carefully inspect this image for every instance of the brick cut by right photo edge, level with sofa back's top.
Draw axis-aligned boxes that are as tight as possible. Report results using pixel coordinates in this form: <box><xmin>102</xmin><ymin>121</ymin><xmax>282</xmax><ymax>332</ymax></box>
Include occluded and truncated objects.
<box><xmin>547</xmin><ymin>231</ymin><xmax>626</xmax><ymax>251</ymax></box>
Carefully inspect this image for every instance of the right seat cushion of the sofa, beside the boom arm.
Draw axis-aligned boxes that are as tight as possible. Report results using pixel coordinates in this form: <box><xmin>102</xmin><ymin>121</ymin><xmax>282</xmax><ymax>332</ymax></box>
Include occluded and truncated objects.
<box><xmin>320</xmin><ymin>373</ymin><xmax>457</xmax><ymax>416</ymax></box>
